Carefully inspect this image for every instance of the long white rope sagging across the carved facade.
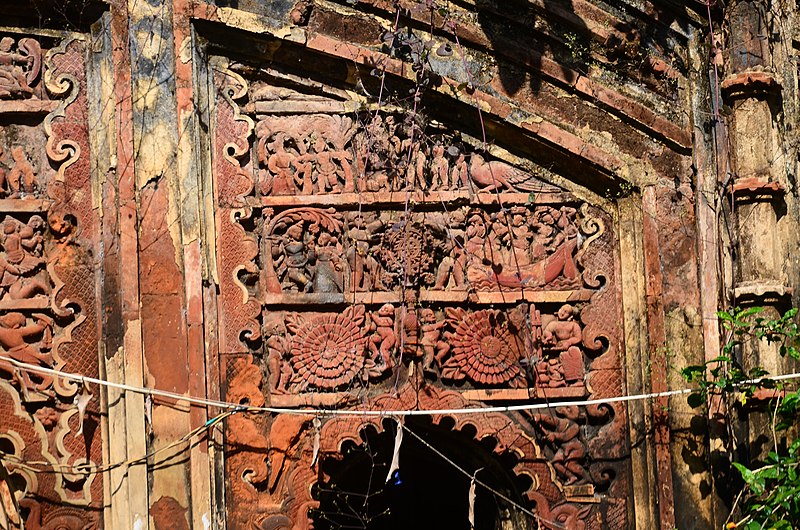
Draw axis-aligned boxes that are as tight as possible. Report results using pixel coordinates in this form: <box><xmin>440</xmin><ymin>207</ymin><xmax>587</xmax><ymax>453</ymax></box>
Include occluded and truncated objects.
<box><xmin>0</xmin><ymin>355</ymin><xmax>800</xmax><ymax>417</ymax></box>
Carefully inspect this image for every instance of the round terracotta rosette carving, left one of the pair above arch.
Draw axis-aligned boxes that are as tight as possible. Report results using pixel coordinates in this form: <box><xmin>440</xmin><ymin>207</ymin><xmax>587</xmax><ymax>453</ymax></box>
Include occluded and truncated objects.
<box><xmin>286</xmin><ymin>305</ymin><xmax>367</xmax><ymax>390</ymax></box>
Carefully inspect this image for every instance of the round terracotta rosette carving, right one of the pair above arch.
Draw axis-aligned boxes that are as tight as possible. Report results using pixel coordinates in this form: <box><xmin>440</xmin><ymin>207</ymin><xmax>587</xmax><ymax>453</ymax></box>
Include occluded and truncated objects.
<box><xmin>442</xmin><ymin>308</ymin><xmax>526</xmax><ymax>388</ymax></box>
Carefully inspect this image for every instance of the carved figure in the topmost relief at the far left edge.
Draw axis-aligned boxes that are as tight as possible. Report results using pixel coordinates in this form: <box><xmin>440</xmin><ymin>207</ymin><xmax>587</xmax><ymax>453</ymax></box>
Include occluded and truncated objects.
<box><xmin>0</xmin><ymin>37</ymin><xmax>42</xmax><ymax>99</ymax></box>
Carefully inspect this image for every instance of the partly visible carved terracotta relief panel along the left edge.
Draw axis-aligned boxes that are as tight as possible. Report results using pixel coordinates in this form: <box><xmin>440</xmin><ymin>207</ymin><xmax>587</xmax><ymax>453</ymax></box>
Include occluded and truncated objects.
<box><xmin>0</xmin><ymin>34</ymin><xmax>103</xmax><ymax>529</ymax></box>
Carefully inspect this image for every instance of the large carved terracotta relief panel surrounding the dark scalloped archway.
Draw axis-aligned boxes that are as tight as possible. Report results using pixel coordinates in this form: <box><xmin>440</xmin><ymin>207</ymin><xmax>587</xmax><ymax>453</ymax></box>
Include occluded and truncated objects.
<box><xmin>210</xmin><ymin>58</ymin><xmax>628</xmax><ymax>528</ymax></box>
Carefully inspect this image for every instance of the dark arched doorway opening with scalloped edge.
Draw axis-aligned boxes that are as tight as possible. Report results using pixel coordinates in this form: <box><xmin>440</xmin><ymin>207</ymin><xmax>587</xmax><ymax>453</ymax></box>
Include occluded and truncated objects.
<box><xmin>314</xmin><ymin>417</ymin><xmax>536</xmax><ymax>530</ymax></box>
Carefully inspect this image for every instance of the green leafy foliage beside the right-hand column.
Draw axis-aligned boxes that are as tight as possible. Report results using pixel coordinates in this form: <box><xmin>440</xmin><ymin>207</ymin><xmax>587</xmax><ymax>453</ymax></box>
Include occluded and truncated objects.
<box><xmin>681</xmin><ymin>307</ymin><xmax>800</xmax><ymax>530</ymax></box>
